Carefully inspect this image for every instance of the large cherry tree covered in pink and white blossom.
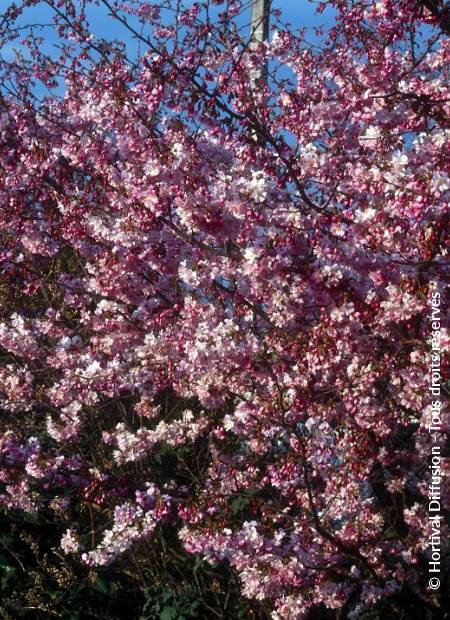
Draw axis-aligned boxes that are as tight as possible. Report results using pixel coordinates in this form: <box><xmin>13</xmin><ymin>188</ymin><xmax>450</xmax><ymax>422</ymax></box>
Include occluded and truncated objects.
<box><xmin>0</xmin><ymin>0</ymin><xmax>450</xmax><ymax>620</ymax></box>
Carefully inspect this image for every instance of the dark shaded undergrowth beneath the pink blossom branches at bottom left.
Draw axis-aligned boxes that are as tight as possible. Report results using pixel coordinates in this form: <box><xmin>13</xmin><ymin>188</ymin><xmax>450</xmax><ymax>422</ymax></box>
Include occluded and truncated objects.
<box><xmin>0</xmin><ymin>510</ymin><xmax>269</xmax><ymax>620</ymax></box>
